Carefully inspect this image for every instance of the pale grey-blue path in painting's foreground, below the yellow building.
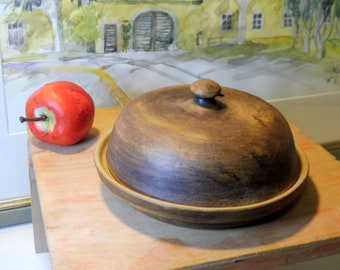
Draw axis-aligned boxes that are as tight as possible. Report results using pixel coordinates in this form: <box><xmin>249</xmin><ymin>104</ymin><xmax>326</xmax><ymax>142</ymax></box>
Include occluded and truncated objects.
<box><xmin>4</xmin><ymin>52</ymin><xmax>340</xmax><ymax>132</ymax></box>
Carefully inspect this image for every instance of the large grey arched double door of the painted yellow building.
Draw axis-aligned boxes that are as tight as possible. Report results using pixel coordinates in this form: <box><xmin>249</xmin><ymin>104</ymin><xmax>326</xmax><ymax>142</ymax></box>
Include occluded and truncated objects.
<box><xmin>133</xmin><ymin>11</ymin><xmax>174</xmax><ymax>51</ymax></box>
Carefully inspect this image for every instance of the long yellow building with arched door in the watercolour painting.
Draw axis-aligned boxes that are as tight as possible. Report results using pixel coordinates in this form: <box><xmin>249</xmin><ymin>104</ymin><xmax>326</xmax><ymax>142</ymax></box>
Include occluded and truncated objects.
<box><xmin>0</xmin><ymin>0</ymin><xmax>294</xmax><ymax>55</ymax></box>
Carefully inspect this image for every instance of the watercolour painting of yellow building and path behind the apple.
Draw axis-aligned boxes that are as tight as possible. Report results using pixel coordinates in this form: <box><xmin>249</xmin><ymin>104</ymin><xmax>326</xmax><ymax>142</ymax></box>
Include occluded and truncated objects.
<box><xmin>0</xmin><ymin>0</ymin><xmax>340</xmax><ymax>133</ymax></box>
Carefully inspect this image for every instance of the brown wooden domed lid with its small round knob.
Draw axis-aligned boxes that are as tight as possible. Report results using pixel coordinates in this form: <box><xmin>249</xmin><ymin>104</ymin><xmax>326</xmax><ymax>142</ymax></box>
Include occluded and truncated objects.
<box><xmin>106</xmin><ymin>79</ymin><xmax>300</xmax><ymax>207</ymax></box>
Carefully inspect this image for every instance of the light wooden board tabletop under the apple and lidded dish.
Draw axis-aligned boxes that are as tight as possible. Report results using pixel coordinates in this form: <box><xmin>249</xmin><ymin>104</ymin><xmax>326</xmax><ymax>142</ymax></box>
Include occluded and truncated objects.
<box><xmin>29</xmin><ymin>108</ymin><xmax>340</xmax><ymax>270</ymax></box>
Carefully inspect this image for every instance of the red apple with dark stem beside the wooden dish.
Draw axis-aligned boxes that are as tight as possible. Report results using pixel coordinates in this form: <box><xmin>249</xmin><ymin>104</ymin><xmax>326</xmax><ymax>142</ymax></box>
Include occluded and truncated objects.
<box><xmin>20</xmin><ymin>81</ymin><xmax>95</xmax><ymax>145</ymax></box>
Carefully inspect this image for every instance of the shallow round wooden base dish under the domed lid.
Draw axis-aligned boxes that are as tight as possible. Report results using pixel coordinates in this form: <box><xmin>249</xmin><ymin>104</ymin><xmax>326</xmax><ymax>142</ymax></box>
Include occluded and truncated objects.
<box><xmin>95</xmin><ymin>134</ymin><xmax>308</xmax><ymax>229</ymax></box>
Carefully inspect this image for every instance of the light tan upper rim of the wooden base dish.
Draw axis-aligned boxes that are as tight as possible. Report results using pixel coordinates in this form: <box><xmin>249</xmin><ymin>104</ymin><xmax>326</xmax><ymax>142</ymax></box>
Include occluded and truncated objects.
<box><xmin>94</xmin><ymin>131</ymin><xmax>309</xmax><ymax>213</ymax></box>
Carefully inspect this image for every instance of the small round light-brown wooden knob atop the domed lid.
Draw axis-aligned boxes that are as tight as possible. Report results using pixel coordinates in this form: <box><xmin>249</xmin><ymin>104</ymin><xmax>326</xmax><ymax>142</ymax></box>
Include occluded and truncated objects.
<box><xmin>190</xmin><ymin>79</ymin><xmax>222</xmax><ymax>98</ymax></box>
